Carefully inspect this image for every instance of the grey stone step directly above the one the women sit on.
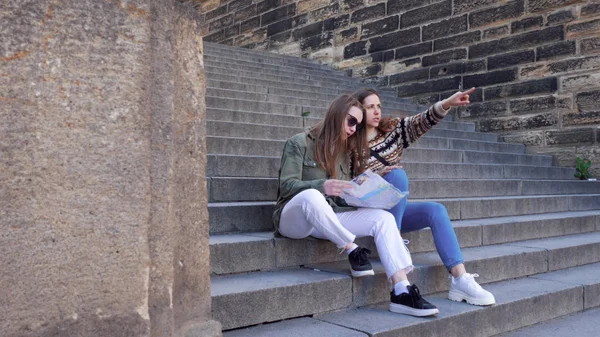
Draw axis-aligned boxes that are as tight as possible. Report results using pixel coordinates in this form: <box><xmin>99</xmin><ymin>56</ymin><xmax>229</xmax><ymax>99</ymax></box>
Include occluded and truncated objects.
<box><xmin>208</xmin><ymin>194</ymin><xmax>600</xmax><ymax>234</ymax></box>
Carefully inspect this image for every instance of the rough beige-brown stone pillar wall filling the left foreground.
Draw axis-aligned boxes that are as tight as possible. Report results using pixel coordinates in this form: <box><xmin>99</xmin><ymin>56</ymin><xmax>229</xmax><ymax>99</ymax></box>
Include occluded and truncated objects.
<box><xmin>0</xmin><ymin>0</ymin><xmax>220</xmax><ymax>337</ymax></box>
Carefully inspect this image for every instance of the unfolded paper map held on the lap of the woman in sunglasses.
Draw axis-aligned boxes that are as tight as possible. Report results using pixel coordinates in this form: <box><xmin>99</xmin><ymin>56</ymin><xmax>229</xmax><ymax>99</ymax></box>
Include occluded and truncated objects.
<box><xmin>340</xmin><ymin>170</ymin><xmax>408</xmax><ymax>209</ymax></box>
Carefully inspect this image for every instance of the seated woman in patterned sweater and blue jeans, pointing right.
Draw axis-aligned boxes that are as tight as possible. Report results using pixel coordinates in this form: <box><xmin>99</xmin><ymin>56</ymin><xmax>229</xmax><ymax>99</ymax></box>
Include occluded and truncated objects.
<box><xmin>354</xmin><ymin>88</ymin><xmax>496</xmax><ymax>305</ymax></box>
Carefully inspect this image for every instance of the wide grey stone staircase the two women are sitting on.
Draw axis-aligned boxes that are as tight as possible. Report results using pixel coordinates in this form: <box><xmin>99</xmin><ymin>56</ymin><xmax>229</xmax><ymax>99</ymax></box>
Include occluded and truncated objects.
<box><xmin>204</xmin><ymin>43</ymin><xmax>600</xmax><ymax>337</ymax></box>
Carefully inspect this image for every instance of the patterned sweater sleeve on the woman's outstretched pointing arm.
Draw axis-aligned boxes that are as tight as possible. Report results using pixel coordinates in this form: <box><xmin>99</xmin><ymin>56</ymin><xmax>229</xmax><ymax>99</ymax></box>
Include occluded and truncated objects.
<box><xmin>395</xmin><ymin>101</ymin><xmax>450</xmax><ymax>148</ymax></box>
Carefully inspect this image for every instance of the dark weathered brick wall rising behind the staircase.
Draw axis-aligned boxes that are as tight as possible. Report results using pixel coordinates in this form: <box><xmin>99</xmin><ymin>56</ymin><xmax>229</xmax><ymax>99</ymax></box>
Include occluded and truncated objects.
<box><xmin>203</xmin><ymin>0</ymin><xmax>600</xmax><ymax>176</ymax></box>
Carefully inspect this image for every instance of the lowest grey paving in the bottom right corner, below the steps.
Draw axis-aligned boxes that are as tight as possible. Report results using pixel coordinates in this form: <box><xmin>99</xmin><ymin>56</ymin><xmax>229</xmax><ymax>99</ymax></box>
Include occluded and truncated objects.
<box><xmin>494</xmin><ymin>304</ymin><xmax>600</xmax><ymax>337</ymax></box>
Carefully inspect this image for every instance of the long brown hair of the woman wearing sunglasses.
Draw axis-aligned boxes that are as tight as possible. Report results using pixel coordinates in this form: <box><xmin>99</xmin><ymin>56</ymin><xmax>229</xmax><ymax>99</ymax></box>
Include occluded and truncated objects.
<box><xmin>310</xmin><ymin>94</ymin><xmax>369</xmax><ymax>179</ymax></box>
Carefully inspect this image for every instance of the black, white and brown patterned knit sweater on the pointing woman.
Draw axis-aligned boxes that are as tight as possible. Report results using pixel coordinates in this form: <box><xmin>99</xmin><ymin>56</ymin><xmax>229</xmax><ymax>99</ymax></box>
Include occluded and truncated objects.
<box><xmin>367</xmin><ymin>102</ymin><xmax>449</xmax><ymax>172</ymax></box>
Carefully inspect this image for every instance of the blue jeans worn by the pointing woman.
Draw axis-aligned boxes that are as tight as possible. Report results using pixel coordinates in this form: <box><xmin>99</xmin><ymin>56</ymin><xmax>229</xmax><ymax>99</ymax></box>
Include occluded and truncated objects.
<box><xmin>383</xmin><ymin>169</ymin><xmax>464</xmax><ymax>271</ymax></box>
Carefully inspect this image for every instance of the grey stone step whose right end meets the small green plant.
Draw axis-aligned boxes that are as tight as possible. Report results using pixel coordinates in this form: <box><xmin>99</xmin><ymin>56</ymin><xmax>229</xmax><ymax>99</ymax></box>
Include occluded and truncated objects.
<box><xmin>206</xmin><ymin>154</ymin><xmax>575</xmax><ymax>180</ymax></box>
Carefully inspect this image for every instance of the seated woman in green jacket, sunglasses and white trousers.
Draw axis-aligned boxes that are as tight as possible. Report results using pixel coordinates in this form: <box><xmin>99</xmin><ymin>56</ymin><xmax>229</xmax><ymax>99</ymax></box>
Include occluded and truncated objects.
<box><xmin>273</xmin><ymin>95</ymin><xmax>439</xmax><ymax>316</ymax></box>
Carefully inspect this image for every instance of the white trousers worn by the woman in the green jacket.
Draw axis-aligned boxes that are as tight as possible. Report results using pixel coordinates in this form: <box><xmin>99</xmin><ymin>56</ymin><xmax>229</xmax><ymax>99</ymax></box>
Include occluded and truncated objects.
<box><xmin>279</xmin><ymin>189</ymin><xmax>413</xmax><ymax>278</ymax></box>
